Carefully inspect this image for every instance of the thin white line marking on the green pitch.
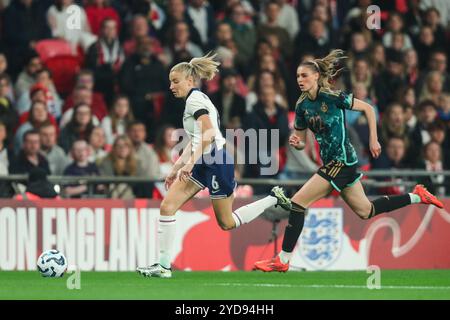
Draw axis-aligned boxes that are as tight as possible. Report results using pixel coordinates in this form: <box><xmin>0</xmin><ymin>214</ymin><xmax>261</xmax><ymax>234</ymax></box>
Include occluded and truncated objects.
<box><xmin>204</xmin><ymin>282</ymin><xmax>450</xmax><ymax>291</ymax></box>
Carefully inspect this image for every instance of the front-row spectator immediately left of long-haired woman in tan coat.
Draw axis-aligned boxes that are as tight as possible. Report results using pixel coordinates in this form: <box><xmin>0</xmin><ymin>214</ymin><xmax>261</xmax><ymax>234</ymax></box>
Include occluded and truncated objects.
<box><xmin>64</xmin><ymin>140</ymin><xmax>101</xmax><ymax>198</ymax></box>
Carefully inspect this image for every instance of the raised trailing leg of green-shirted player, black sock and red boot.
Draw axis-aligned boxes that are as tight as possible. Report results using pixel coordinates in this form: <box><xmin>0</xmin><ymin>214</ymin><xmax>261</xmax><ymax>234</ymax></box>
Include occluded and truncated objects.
<box><xmin>341</xmin><ymin>181</ymin><xmax>443</xmax><ymax>219</ymax></box>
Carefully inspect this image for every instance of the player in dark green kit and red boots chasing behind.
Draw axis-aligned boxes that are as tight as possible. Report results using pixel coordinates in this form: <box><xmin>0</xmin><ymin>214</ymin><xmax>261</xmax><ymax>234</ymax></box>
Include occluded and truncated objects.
<box><xmin>254</xmin><ymin>50</ymin><xmax>443</xmax><ymax>272</ymax></box>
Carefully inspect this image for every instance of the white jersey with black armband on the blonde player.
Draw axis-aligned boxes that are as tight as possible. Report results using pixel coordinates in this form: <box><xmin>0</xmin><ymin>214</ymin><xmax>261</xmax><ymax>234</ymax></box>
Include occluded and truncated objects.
<box><xmin>183</xmin><ymin>88</ymin><xmax>225</xmax><ymax>154</ymax></box>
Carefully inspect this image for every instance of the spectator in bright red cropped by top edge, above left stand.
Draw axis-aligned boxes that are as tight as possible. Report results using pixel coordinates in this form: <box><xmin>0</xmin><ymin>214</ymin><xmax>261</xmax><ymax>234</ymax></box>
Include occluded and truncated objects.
<box><xmin>86</xmin><ymin>0</ymin><xmax>121</xmax><ymax>36</ymax></box>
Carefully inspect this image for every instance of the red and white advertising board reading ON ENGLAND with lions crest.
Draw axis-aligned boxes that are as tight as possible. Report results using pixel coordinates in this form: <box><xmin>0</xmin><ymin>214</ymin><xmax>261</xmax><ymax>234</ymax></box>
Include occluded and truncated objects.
<box><xmin>0</xmin><ymin>198</ymin><xmax>450</xmax><ymax>271</ymax></box>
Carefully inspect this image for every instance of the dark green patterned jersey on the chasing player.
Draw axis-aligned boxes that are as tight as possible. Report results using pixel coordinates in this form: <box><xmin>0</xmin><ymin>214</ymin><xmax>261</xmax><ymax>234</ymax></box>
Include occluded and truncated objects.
<box><xmin>294</xmin><ymin>88</ymin><xmax>358</xmax><ymax>166</ymax></box>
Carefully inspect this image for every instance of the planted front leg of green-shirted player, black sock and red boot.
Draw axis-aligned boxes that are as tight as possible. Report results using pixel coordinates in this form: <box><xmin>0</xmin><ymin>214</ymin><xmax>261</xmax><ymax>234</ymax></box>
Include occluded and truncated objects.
<box><xmin>254</xmin><ymin>174</ymin><xmax>333</xmax><ymax>272</ymax></box>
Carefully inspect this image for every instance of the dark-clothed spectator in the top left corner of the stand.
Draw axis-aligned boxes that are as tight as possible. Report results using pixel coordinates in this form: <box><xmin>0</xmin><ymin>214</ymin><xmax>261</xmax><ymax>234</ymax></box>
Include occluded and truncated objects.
<box><xmin>2</xmin><ymin>0</ymin><xmax>51</xmax><ymax>79</ymax></box>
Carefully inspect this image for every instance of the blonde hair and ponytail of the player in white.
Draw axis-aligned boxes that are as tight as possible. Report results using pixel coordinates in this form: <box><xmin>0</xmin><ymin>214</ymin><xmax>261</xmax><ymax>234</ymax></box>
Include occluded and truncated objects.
<box><xmin>170</xmin><ymin>52</ymin><xmax>220</xmax><ymax>80</ymax></box>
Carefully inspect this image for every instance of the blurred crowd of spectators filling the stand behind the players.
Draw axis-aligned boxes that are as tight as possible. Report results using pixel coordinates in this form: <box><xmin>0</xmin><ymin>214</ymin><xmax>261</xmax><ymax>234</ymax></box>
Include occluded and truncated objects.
<box><xmin>0</xmin><ymin>0</ymin><xmax>450</xmax><ymax>198</ymax></box>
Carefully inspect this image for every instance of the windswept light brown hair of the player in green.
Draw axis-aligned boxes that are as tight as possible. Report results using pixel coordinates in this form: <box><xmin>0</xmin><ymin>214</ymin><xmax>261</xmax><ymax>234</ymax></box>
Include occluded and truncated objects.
<box><xmin>300</xmin><ymin>49</ymin><xmax>347</xmax><ymax>90</ymax></box>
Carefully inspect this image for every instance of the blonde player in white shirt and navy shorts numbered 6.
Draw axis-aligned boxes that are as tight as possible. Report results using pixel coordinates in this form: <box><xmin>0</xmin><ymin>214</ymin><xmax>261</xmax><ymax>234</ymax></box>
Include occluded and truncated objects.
<box><xmin>137</xmin><ymin>54</ymin><xmax>291</xmax><ymax>278</ymax></box>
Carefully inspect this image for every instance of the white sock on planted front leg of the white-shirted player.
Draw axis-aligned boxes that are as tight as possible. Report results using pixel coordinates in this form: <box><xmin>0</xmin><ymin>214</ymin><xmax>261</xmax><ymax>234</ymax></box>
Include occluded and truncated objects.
<box><xmin>158</xmin><ymin>215</ymin><xmax>176</xmax><ymax>269</ymax></box>
